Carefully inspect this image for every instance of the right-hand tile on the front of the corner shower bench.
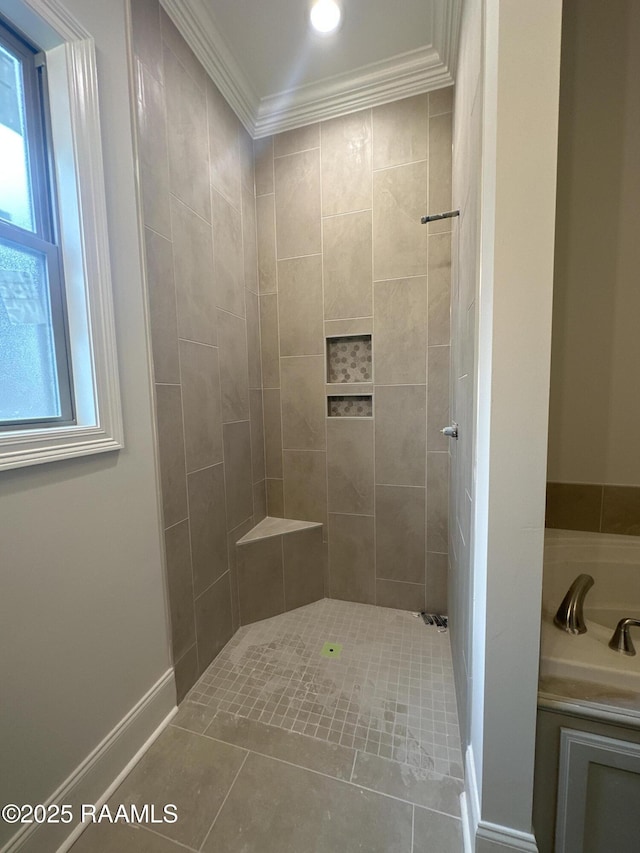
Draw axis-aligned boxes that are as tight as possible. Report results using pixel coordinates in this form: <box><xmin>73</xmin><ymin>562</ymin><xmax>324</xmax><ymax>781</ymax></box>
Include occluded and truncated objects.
<box><xmin>282</xmin><ymin>527</ymin><xmax>325</xmax><ymax>610</ymax></box>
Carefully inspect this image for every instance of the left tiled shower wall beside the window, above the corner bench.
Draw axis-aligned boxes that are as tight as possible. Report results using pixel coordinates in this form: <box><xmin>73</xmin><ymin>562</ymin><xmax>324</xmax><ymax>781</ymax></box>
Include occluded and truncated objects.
<box><xmin>131</xmin><ymin>0</ymin><xmax>266</xmax><ymax>699</ymax></box>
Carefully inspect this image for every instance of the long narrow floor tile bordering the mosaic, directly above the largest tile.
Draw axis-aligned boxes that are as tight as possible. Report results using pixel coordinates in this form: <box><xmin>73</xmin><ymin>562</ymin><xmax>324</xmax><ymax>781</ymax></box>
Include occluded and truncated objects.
<box><xmin>205</xmin><ymin>711</ymin><xmax>355</xmax><ymax>781</ymax></box>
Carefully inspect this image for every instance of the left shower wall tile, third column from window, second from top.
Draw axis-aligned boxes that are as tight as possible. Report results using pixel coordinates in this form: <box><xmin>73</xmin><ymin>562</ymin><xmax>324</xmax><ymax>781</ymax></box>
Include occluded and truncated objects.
<box><xmin>211</xmin><ymin>190</ymin><xmax>245</xmax><ymax>317</ymax></box>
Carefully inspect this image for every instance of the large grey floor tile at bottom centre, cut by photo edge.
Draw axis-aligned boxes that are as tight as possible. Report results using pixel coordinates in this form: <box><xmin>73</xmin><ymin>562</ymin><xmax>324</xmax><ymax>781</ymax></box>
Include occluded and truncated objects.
<box><xmin>203</xmin><ymin>754</ymin><xmax>412</xmax><ymax>853</ymax></box>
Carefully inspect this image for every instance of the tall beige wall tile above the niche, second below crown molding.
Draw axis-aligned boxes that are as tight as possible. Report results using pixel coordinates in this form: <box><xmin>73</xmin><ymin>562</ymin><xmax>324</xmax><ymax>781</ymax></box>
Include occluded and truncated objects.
<box><xmin>322</xmin><ymin>210</ymin><xmax>373</xmax><ymax>320</ymax></box>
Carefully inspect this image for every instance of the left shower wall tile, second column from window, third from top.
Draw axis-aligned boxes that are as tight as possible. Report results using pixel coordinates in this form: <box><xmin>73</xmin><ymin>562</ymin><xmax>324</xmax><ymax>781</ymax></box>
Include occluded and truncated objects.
<box><xmin>180</xmin><ymin>341</ymin><xmax>222</xmax><ymax>471</ymax></box>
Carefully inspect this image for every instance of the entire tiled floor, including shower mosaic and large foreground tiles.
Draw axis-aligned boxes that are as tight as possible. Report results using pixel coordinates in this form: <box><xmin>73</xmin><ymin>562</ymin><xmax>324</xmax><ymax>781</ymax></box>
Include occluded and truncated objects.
<box><xmin>72</xmin><ymin>599</ymin><xmax>463</xmax><ymax>853</ymax></box>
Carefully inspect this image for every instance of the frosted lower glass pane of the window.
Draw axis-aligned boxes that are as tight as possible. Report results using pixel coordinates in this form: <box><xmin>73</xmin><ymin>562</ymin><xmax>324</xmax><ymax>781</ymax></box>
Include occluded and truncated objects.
<box><xmin>0</xmin><ymin>240</ymin><xmax>61</xmax><ymax>423</ymax></box>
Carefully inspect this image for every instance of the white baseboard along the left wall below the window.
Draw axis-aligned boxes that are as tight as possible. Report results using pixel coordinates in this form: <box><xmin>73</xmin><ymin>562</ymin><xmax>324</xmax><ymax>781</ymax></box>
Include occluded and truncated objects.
<box><xmin>0</xmin><ymin>669</ymin><xmax>177</xmax><ymax>853</ymax></box>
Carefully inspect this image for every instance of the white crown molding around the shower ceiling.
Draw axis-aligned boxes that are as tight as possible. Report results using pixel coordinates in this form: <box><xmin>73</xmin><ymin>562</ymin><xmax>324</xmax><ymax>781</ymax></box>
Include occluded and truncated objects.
<box><xmin>161</xmin><ymin>0</ymin><xmax>462</xmax><ymax>139</ymax></box>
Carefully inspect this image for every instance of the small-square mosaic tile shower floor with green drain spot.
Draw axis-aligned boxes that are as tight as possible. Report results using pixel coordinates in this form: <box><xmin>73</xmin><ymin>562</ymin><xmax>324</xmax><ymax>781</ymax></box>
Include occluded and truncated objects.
<box><xmin>185</xmin><ymin>599</ymin><xmax>462</xmax><ymax>779</ymax></box>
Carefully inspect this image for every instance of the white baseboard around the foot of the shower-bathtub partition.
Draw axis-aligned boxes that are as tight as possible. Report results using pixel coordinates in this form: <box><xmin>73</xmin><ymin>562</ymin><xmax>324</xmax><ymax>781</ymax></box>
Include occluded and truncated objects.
<box><xmin>461</xmin><ymin>745</ymin><xmax>538</xmax><ymax>853</ymax></box>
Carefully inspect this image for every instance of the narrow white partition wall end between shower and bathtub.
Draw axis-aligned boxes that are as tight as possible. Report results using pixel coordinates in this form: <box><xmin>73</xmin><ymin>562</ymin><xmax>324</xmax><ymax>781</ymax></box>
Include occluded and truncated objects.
<box><xmin>453</xmin><ymin>0</ymin><xmax>562</xmax><ymax>853</ymax></box>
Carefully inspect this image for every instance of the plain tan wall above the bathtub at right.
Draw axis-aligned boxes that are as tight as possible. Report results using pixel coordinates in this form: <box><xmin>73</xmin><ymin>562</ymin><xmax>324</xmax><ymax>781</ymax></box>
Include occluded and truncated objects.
<box><xmin>548</xmin><ymin>0</ymin><xmax>640</xmax><ymax>486</ymax></box>
